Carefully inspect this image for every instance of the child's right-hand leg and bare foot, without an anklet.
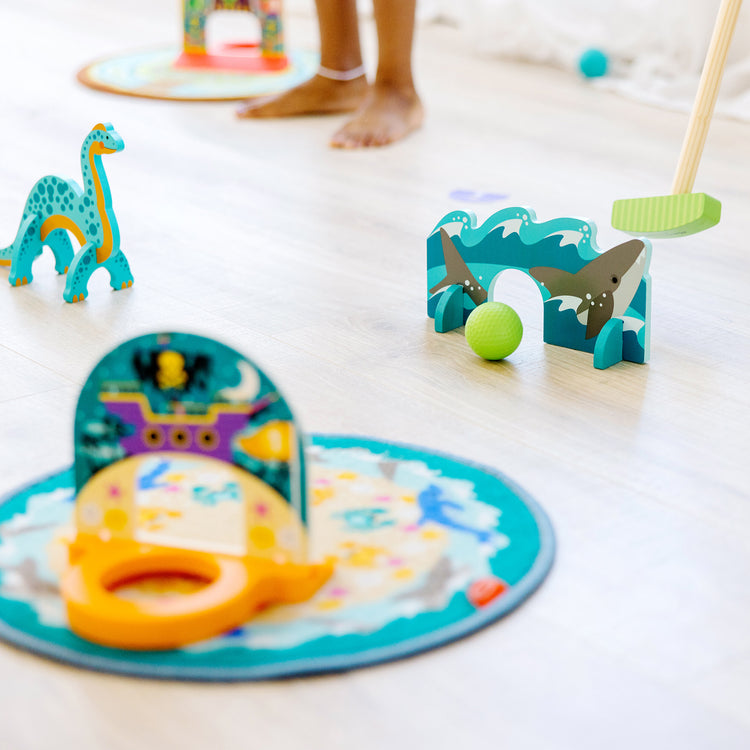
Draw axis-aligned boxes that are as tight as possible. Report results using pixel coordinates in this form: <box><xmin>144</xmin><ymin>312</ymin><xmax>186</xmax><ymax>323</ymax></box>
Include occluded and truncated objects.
<box><xmin>331</xmin><ymin>0</ymin><xmax>423</xmax><ymax>148</ymax></box>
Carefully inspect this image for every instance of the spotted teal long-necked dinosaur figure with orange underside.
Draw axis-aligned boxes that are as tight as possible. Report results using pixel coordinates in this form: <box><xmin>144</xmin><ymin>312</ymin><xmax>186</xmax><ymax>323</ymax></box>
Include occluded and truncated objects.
<box><xmin>0</xmin><ymin>123</ymin><xmax>133</xmax><ymax>302</ymax></box>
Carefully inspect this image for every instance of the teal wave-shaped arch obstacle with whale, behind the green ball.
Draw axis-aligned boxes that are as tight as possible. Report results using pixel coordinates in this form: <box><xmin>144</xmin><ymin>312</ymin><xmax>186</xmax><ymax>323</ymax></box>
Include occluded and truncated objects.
<box><xmin>427</xmin><ymin>206</ymin><xmax>651</xmax><ymax>369</ymax></box>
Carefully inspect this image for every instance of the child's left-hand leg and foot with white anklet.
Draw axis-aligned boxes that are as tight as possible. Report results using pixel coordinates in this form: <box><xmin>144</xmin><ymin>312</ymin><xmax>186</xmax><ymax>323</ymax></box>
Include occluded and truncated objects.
<box><xmin>237</xmin><ymin>0</ymin><xmax>367</xmax><ymax>117</ymax></box>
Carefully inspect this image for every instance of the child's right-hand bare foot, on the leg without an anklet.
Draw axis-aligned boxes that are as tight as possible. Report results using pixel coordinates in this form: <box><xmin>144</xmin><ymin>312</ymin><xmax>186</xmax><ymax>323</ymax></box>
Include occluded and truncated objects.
<box><xmin>331</xmin><ymin>84</ymin><xmax>424</xmax><ymax>148</ymax></box>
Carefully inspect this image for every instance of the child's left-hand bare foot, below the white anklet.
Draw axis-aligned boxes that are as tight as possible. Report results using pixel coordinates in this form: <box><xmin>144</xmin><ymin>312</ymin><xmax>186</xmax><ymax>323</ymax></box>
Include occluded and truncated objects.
<box><xmin>237</xmin><ymin>75</ymin><xmax>367</xmax><ymax>117</ymax></box>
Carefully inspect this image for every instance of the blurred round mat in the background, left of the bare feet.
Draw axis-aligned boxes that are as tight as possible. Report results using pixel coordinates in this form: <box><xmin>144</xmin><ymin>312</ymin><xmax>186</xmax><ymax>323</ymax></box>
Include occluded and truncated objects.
<box><xmin>78</xmin><ymin>47</ymin><xmax>319</xmax><ymax>101</ymax></box>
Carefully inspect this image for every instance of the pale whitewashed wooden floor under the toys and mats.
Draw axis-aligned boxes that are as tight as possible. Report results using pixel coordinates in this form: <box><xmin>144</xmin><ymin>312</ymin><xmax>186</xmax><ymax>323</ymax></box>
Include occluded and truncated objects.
<box><xmin>0</xmin><ymin>0</ymin><xmax>750</xmax><ymax>750</ymax></box>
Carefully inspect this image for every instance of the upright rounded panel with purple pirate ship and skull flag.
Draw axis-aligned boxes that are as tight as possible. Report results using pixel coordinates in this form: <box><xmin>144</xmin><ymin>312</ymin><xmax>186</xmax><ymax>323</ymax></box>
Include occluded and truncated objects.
<box><xmin>74</xmin><ymin>333</ymin><xmax>307</xmax><ymax>559</ymax></box>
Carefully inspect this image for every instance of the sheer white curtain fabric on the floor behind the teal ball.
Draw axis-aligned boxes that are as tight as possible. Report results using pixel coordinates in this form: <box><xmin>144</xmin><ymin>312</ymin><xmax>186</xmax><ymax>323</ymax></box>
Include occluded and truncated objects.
<box><xmin>287</xmin><ymin>0</ymin><xmax>750</xmax><ymax>120</ymax></box>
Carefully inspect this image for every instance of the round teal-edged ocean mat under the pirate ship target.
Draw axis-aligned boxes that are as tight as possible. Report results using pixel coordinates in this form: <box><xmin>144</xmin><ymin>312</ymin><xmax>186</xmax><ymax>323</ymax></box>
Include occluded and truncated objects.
<box><xmin>0</xmin><ymin>435</ymin><xmax>554</xmax><ymax>681</ymax></box>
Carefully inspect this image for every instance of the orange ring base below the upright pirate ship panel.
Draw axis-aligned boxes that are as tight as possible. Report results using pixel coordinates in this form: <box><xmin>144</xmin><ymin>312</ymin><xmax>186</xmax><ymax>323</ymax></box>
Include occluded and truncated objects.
<box><xmin>60</xmin><ymin>540</ymin><xmax>332</xmax><ymax>650</ymax></box>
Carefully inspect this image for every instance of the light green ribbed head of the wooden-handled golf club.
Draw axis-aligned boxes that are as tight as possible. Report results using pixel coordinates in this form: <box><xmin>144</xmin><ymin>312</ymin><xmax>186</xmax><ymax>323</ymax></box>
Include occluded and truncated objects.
<box><xmin>612</xmin><ymin>193</ymin><xmax>721</xmax><ymax>238</ymax></box>
